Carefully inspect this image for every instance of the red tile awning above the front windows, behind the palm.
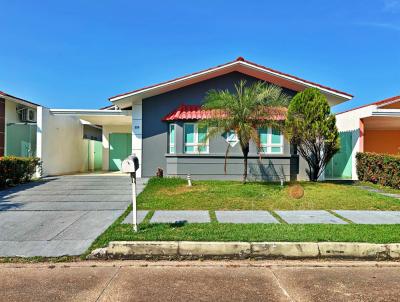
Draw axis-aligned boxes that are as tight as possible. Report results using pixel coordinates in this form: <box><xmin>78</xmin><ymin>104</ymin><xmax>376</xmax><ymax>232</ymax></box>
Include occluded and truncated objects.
<box><xmin>162</xmin><ymin>105</ymin><xmax>287</xmax><ymax>122</ymax></box>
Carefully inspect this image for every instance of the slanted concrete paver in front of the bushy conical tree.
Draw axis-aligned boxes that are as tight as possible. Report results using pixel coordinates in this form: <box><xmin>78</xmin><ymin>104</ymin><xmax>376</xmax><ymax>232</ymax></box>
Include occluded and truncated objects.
<box><xmin>275</xmin><ymin>210</ymin><xmax>347</xmax><ymax>224</ymax></box>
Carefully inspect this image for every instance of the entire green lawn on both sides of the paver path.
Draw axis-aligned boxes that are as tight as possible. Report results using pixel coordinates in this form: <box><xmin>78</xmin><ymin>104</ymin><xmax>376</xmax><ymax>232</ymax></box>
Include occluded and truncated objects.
<box><xmin>88</xmin><ymin>179</ymin><xmax>400</xmax><ymax>252</ymax></box>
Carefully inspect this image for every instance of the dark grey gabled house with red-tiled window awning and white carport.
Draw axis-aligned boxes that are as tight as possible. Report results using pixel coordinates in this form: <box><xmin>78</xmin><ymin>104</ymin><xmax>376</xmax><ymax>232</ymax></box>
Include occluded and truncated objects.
<box><xmin>3</xmin><ymin>57</ymin><xmax>352</xmax><ymax>180</ymax></box>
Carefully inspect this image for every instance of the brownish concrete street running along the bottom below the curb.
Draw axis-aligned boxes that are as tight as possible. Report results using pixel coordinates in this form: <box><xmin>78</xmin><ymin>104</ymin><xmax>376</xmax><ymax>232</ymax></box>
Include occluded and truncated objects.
<box><xmin>0</xmin><ymin>260</ymin><xmax>400</xmax><ymax>302</ymax></box>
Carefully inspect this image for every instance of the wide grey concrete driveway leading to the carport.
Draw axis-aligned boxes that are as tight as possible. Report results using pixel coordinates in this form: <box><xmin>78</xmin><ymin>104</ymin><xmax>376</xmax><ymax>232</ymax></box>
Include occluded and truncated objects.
<box><xmin>0</xmin><ymin>174</ymin><xmax>145</xmax><ymax>257</ymax></box>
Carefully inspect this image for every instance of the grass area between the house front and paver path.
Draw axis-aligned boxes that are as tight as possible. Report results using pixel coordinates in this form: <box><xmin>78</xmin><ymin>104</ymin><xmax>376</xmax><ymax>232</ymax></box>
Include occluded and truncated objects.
<box><xmin>138</xmin><ymin>178</ymin><xmax>400</xmax><ymax>210</ymax></box>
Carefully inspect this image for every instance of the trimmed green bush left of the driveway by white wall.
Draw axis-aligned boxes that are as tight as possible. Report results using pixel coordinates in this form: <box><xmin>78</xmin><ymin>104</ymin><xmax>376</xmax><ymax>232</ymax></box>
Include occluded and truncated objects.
<box><xmin>0</xmin><ymin>156</ymin><xmax>40</xmax><ymax>187</ymax></box>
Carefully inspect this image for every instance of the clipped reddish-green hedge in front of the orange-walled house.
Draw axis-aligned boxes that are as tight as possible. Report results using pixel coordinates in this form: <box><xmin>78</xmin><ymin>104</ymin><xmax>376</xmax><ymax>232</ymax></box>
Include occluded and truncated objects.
<box><xmin>356</xmin><ymin>152</ymin><xmax>400</xmax><ymax>189</ymax></box>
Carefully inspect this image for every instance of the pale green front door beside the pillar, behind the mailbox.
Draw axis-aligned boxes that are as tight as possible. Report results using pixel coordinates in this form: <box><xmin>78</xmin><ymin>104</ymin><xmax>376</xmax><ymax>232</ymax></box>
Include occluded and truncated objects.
<box><xmin>109</xmin><ymin>133</ymin><xmax>132</xmax><ymax>171</ymax></box>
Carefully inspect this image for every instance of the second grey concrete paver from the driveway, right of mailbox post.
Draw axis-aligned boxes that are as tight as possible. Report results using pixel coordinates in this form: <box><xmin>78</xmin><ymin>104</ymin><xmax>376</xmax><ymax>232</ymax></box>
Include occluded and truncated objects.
<box><xmin>150</xmin><ymin>211</ymin><xmax>211</xmax><ymax>223</ymax></box>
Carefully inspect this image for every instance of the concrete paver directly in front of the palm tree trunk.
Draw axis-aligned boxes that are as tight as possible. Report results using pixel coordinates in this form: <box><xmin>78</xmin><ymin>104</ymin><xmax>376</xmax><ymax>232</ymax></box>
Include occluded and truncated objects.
<box><xmin>215</xmin><ymin>211</ymin><xmax>279</xmax><ymax>223</ymax></box>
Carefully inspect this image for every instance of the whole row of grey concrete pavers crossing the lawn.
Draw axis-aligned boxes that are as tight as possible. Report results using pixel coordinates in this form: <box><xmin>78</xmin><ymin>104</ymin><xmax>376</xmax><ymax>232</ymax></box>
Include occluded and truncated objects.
<box><xmin>123</xmin><ymin>210</ymin><xmax>400</xmax><ymax>224</ymax></box>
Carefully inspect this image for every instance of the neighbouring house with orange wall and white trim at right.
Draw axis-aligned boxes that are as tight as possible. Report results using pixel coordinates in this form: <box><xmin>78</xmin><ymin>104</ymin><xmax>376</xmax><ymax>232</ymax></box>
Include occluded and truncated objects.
<box><xmin>325</xmin><ymin>96</ymin><xmax>400</xmax><ymax>180</ymax></box>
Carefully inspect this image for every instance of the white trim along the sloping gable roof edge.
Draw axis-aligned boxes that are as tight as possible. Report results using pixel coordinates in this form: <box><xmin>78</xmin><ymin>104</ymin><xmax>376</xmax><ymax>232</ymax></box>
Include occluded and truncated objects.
<box><xmin>110</xmin><ymin>61</ymin><xmax>353</xmax><ymax>102</ymax></box>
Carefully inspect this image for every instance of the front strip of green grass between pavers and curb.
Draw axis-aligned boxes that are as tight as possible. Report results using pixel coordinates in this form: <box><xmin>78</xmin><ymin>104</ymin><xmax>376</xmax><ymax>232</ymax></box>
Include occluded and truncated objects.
<box><xmin>84</xmin><ymin>207</ymin><xmax>400</xmax><ymax>256</ymax></box>
